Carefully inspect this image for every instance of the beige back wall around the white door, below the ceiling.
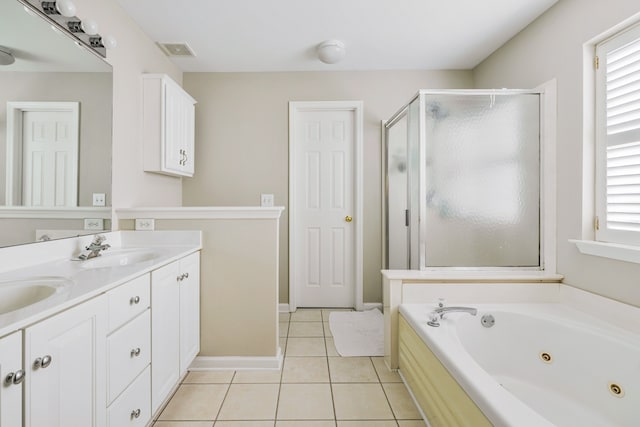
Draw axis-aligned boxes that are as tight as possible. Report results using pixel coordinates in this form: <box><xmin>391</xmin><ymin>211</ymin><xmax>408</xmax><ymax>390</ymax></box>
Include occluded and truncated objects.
<box><xmin>183</xmin><ymin>71</ymin><xmax>472</xmax><ymax>303</ymax></box>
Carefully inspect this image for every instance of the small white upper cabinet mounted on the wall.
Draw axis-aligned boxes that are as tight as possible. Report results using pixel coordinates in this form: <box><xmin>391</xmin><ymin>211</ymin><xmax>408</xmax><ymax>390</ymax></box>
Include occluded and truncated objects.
<box><xmin>142</xmin><ymin>74</ymin><xmax>196</xmax><ymax>177</ymax></box>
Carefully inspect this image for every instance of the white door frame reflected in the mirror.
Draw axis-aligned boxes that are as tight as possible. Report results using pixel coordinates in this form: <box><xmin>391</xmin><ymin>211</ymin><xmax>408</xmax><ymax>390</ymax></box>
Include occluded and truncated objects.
<box><xmin>5</xmin><ymin>101</ymin><xmax>80</xmax><ymax>206</ymax></box>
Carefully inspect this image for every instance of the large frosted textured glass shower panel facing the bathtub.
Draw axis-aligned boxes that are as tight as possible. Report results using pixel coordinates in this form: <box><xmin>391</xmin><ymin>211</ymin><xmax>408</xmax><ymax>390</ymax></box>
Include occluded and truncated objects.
<box><xmin>422</xmin><ymin>94</ymin><xmax>540</xmax><ymax>267</ymax></box>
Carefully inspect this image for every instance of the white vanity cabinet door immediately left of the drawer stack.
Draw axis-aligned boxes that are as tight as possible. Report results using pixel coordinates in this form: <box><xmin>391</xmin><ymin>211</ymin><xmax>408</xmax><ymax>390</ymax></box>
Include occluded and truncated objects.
<box><xmin>24</xmin><ymin>297</ymin><xmax>106</xmax><ymax>427</ymax></box>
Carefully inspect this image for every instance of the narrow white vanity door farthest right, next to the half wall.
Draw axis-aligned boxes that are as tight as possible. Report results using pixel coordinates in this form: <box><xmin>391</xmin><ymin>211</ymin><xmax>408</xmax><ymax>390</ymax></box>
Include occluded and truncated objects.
<box><xmin>178</xmin><ymin>252</ymin><xmax>200</xmax><ymax>375</ymax></box>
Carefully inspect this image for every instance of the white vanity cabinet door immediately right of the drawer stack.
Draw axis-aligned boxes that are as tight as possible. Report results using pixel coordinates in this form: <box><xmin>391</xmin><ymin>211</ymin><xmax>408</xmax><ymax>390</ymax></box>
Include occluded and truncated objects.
<box><xmin>151</xmin><ymin>262</ymin><xmax>180</xmax><ymax>414</ymax></box>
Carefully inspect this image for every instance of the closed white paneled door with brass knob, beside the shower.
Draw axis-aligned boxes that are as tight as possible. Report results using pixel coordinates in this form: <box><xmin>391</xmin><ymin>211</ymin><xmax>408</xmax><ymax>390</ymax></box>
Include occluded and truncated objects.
<box><xmin>289</xmin><ymin>103</ymin><xmax>362</xmax><ymax>307</ymax></box>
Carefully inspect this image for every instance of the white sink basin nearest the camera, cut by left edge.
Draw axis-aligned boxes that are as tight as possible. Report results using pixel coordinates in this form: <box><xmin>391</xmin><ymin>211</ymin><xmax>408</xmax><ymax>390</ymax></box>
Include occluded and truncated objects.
<box><xmin>0</xmin><ymin>277</ymin><xmax>72</xmax><ymax>314</ymax></box>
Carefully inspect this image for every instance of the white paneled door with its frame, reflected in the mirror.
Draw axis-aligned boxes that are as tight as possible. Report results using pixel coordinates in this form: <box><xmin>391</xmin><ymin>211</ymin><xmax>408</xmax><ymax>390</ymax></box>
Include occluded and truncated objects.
<box><xmin>7</xmin><ymin>102</ymin><xmax>79</xmax><ymax>208</ymax></box>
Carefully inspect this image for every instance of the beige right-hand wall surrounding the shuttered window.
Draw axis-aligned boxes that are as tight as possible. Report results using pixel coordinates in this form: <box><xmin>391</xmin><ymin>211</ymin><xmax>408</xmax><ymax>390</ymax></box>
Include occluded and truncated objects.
<box><xmin>473</xmin><ymin>0</ymin><xmax>640</xmax><ymax>306</ymax></box>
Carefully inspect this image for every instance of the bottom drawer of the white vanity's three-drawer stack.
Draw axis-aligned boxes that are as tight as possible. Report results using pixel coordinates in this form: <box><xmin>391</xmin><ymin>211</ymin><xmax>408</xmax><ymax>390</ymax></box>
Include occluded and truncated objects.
<box><xmin>107</xmin><ymin>366</ymin><xmax>151</xmax><ymax>427</ymax></box>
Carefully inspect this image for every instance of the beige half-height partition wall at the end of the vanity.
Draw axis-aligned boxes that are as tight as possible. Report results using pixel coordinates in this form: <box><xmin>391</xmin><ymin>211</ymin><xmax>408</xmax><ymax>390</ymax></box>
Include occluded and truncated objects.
<box><xmin>120</xmin><ymin>213</ymin><xmax>284</xmax><ymax>360</ymax></box>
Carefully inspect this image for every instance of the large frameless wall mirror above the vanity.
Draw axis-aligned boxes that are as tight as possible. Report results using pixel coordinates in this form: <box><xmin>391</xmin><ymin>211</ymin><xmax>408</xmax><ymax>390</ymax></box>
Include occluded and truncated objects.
<box><xmin>0</xmin><ymin>0</ymin><xmax>113</xmax><ymax>247</ymax></box>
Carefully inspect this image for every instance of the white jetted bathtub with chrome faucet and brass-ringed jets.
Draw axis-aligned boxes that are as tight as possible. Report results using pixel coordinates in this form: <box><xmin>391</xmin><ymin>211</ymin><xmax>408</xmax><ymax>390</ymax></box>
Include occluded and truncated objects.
<box><xmin>400</xmin><ymin>303</ymin><xmax>640</xmax><ymax>427</ymax></box>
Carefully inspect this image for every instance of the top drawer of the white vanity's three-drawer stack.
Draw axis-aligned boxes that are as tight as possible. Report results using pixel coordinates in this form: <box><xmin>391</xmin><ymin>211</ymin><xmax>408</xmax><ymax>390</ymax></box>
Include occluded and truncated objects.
<box><xmin>107</xmin><ymin>274</ymin><xmax>151</xmax><ymax>331</ymax></box>
